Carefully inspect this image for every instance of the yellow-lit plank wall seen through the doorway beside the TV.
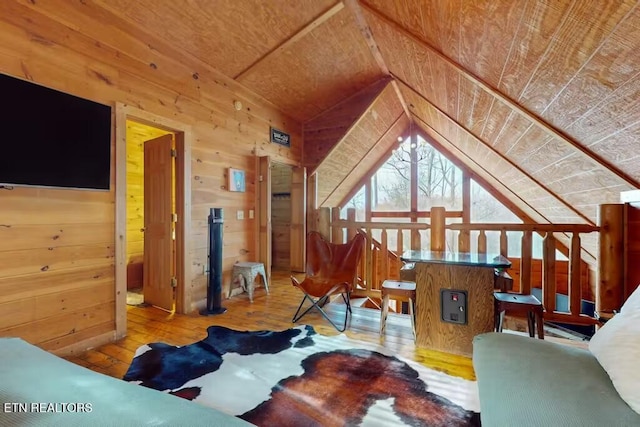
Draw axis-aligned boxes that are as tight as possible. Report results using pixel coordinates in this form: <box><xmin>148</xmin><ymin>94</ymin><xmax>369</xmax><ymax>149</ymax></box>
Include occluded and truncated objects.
<box><xmin>126</xmin><ymin>120</ymin><xmax>169</xmax><ymax>289</ymax></box>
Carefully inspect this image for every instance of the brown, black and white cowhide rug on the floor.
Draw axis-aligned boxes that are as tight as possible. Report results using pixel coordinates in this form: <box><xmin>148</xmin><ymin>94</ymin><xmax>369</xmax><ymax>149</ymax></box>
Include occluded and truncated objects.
<box><xmin>124</xmin><ymin>326</ymin><xmax>480</xmax><ymax>426</ymax></box>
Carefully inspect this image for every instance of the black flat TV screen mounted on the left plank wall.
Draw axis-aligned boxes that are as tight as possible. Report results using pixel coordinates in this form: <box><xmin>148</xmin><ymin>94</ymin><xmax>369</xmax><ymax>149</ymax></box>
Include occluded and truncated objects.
<box><xmin>0</xmin><ymin>74</ymin><xmax>111</xmax><ymax>190</ymax></box>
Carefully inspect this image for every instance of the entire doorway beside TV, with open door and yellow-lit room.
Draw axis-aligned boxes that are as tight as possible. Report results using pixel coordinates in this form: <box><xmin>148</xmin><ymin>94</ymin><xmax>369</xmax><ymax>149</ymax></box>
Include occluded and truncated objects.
<box><xmin>115</xmin><ymin>104</ymin><xmax>192</xmax><ymax>338</ymax></box>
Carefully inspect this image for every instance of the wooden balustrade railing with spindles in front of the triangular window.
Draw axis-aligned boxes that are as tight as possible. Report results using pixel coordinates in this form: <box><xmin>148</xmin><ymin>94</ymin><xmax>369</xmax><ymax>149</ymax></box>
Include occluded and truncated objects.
<box><xmin>318</xmin><ymin>208</ymin><xmax>599</xmax><ymax>325</ymax></box>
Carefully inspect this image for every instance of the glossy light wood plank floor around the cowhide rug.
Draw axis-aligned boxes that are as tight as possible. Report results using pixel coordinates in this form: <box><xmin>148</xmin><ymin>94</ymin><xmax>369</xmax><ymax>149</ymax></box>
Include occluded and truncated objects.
<box><xmin>66</xmin><ymin>272</ymin><xmax>475</xmax><ymax>379</ymax></box>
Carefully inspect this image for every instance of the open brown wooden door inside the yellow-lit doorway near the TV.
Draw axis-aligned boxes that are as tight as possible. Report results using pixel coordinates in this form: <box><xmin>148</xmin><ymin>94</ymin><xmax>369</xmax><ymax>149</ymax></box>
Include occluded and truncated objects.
<box><xmin>143</xmin><ymin>134</ymin><xmax>174</xmax><ymax>311</ymax></box>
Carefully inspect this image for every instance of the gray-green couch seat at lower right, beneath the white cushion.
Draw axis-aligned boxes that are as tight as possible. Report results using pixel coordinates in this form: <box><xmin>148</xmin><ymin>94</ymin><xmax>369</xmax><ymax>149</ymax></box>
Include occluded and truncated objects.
<box><xmin>473</xmin><ymin>332</ymin><xmax>640</xmax><ymax>427</ymax></box>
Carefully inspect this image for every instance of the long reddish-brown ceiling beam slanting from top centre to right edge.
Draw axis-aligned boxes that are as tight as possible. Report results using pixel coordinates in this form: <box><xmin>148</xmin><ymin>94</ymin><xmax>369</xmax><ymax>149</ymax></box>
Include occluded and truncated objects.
<box><xmin>360</xmin><ymin>0</ymin><xmax>640</xmax><ymax>188</ymax></box>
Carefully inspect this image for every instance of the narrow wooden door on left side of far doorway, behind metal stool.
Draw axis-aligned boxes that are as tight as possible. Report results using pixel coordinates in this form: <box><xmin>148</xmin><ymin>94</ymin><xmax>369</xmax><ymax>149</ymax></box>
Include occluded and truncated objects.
<box><xmin>258</xmin><ymin>156</ymin><xmax>271</xmax><ymax>278</ymax></box>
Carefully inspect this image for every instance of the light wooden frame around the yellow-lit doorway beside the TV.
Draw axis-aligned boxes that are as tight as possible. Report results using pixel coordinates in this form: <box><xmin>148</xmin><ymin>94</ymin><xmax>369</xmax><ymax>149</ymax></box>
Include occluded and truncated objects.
<box><xmin>114</xmin><ymin>103</ymin><xmax>193</xmax><ymax>339</ymax></box>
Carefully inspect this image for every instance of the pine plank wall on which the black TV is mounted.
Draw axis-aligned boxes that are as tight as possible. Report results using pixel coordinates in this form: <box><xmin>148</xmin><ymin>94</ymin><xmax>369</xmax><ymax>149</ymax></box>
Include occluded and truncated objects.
<box><xmin>0</xmin><ymin>1</ymin><xmax>302</xmax><ymax>353</ymax></box>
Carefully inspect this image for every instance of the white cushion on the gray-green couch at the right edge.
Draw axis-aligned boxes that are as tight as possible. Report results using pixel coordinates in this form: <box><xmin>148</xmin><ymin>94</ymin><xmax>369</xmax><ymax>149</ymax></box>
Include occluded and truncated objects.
<box><xmin>589</xmin><ymin>288</ymin><xmax>640</xmax><ymax>414</ymax></box>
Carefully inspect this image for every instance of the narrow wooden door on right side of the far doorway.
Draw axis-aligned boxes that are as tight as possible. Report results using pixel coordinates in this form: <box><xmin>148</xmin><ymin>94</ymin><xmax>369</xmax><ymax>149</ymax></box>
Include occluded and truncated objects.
<box><xmin>290</xmin><ymin>167</ymin><xmax>307</xmax><ymax>272</ymax></box>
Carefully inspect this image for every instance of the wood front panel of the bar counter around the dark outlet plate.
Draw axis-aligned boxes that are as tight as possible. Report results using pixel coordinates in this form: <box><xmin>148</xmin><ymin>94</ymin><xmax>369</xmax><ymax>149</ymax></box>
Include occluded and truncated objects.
<box><xmin>415</xmin><ymin>262</ymin><xmax>494</xmax><ymax>356</ymax></box>
